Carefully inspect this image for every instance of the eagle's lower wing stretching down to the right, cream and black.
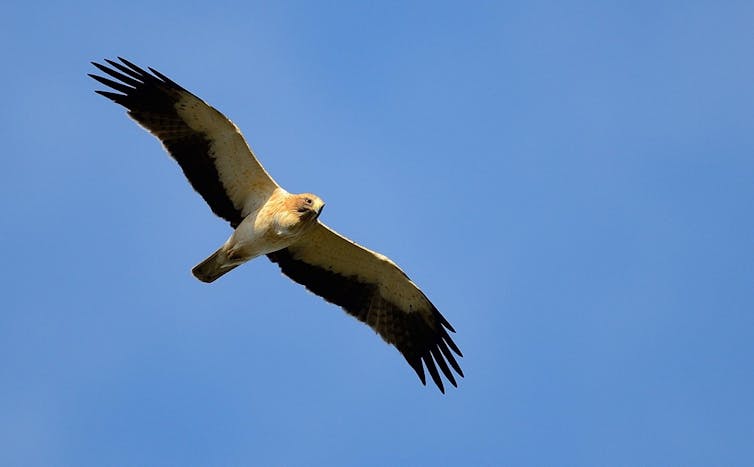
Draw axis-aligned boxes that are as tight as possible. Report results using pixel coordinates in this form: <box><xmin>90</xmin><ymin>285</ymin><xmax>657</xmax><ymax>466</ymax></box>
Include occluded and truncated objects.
<box><xmin>267</xmin><ymin>223</ymin><xmax>463</xmax><ymax>392</ymax></box>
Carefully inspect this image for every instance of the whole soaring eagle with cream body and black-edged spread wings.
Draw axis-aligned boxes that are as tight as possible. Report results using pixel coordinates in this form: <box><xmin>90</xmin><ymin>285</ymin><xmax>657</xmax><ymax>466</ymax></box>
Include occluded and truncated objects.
<box><xmin>89</xmin><ymin>57</ymin><xmax>463</xmax><ymax>393</ymax></box>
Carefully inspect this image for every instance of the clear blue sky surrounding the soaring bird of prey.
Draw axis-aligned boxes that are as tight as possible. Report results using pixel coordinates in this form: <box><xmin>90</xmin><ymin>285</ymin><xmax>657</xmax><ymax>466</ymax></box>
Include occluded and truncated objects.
<box><xmin>0</xmin><ymin>0</ymin><xmax>754</xmax><ymax>466</ymax></box>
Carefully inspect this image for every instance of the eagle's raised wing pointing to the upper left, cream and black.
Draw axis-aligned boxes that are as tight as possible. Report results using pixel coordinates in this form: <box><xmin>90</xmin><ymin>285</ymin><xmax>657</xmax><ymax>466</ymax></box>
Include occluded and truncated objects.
<box><xmin>89</xmin><ymin>58</ymin><xmax>278</xmax><ymax>227</ymax></box>
